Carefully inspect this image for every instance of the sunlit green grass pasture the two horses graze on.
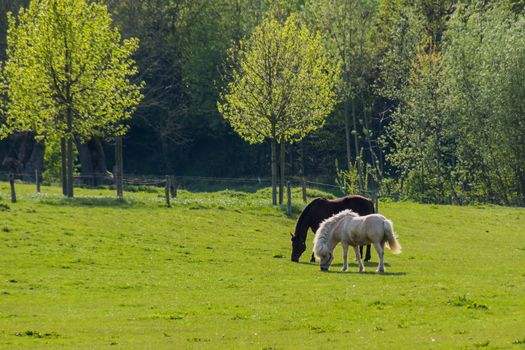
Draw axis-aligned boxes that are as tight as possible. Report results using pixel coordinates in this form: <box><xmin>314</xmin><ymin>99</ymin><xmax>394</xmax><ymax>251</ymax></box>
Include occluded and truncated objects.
<box><xmin>0</xmin><ymin>183</ymin><xmax>525</xmax><ymax>349</ymax></box>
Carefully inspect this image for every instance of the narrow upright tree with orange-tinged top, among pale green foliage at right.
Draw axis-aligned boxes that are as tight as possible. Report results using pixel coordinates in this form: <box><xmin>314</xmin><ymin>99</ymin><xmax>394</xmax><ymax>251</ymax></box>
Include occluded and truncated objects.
<box><xmin>388</xmin><ymin>48</ymin><xmax>456</xmax><ymax>203</ymax></box>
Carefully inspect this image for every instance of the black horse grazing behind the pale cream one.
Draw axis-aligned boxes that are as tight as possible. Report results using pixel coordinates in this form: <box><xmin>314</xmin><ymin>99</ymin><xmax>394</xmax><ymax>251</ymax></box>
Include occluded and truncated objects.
<box><xmin>292</xmin><ymin>196</ymin><xmax>375</xmax><ymax>262</ymax></box>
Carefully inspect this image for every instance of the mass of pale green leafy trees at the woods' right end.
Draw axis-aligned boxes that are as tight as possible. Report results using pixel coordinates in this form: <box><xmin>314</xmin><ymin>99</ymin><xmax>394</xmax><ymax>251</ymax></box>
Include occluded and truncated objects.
<box><xmin>386</xmin><ymin>2</ymin><xmax>525</xmax><ymax>204</ymax></box>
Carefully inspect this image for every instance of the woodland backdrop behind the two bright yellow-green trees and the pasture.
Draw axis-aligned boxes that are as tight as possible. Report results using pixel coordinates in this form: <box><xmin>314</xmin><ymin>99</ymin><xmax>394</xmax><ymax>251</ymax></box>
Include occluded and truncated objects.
<box><xmin>0</xmin><ymin>0</ymin><xmax>525</xmax><ymax>204</ymax></box>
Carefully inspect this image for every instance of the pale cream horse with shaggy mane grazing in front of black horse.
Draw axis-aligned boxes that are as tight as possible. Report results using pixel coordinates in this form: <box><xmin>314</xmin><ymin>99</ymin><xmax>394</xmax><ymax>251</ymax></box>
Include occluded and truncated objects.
<box><xmin>314</xmin><ymin>210</ymin><xmax>401</xmax><ymax>272</ymax></box>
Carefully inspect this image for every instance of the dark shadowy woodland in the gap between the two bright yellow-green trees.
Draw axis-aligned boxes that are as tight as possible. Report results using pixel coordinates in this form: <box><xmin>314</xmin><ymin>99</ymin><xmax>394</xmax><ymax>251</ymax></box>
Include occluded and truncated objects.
<box><xmin>106</xmin><ymin>0</ymin><xmax>269</xmax><ymax>176</ymax></box>
